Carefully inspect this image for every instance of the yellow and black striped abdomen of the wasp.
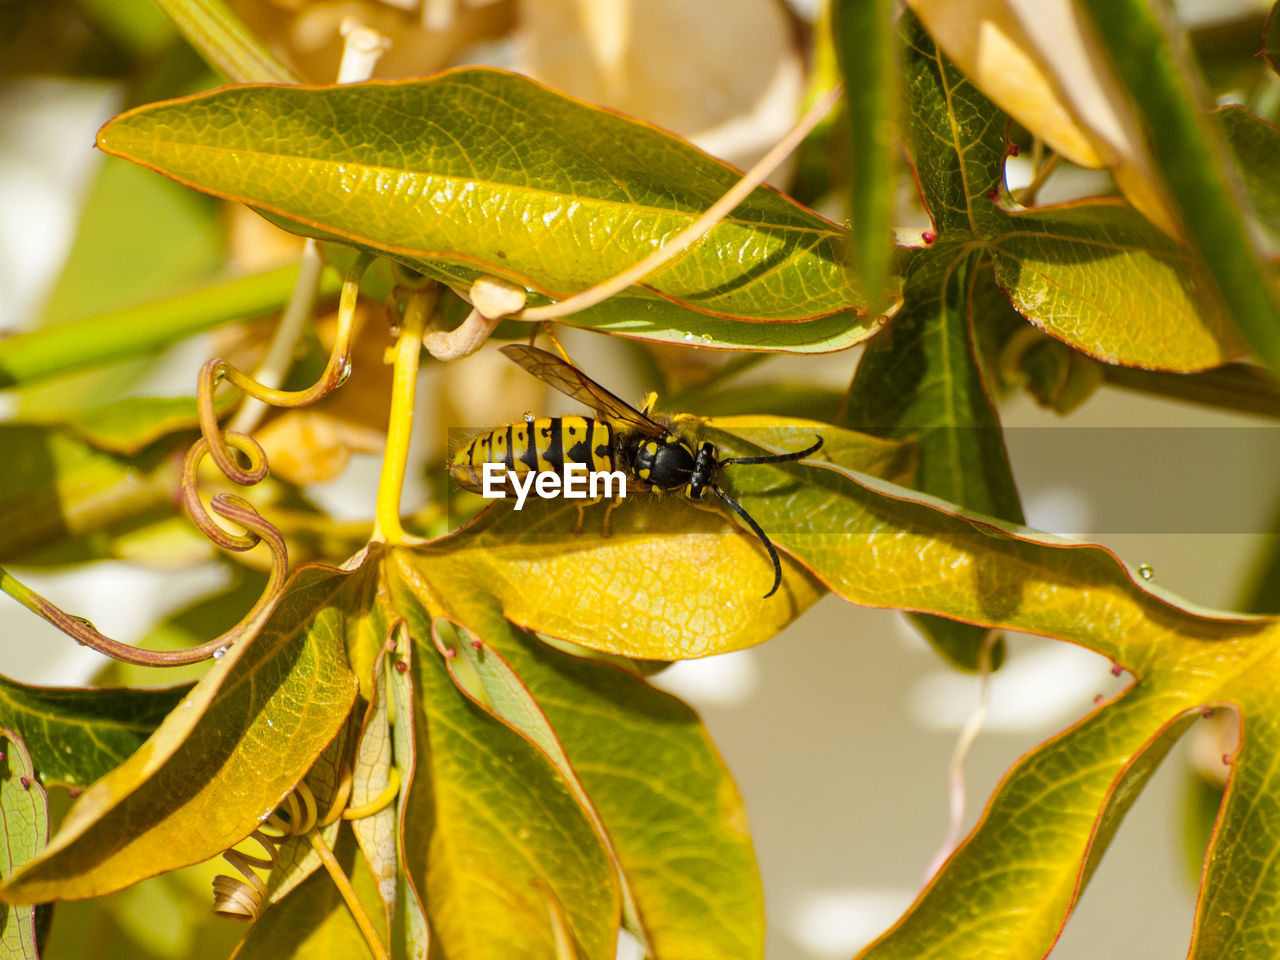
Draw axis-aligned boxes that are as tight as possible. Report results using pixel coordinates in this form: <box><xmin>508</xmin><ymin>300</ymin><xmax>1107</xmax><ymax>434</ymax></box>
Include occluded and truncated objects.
<box><xmin>449</xmin><ymin>416</ymin><xmax>616</xmax><ymax>497</ymax></box>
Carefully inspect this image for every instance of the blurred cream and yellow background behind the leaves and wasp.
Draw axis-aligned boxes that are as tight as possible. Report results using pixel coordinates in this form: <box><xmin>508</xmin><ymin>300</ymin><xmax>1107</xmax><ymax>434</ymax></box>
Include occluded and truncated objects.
<box><xmin>0</xmin><ymin>0</ymin><xmax>1280</xmax><ymax>960</ymax></box>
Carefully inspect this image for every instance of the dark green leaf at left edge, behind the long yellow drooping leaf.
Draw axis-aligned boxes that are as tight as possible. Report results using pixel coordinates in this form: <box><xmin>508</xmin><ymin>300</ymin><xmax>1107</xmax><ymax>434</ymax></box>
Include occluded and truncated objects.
<box><xmin>0</xmin><ymin>676</ymin><xmax>191</xmax><ymax>787</ymax></box>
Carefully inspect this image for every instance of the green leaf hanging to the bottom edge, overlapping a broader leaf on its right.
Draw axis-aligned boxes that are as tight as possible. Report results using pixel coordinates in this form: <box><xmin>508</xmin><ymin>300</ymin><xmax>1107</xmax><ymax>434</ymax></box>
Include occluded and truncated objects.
<box><xmin>389</xmin><ymin>563</ymin><xmax>620</xmax><ymax>960</ymax></box>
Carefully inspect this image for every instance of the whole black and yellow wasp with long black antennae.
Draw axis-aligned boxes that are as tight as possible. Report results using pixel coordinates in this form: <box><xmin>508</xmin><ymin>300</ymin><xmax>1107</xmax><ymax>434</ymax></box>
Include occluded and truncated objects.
<box><xmin>449</xmin><ymin>344</ymin><xmax>822</xmax><ymax>598</ymax></box>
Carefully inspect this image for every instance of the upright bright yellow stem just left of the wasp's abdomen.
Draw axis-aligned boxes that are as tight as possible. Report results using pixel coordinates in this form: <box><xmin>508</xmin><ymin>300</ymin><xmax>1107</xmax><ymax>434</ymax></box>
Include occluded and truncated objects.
<box><xmin>372</xmin><ymin>287</ymin><xmax>438</xmax><ymax>545</ymax></box>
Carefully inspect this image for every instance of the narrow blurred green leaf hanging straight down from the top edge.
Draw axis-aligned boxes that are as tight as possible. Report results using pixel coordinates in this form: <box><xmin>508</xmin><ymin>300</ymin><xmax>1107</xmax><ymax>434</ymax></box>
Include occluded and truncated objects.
<box><xmin>831</xmin><ymin>0</ymin><xmax>899</xmax><ymax>312</ymax></box>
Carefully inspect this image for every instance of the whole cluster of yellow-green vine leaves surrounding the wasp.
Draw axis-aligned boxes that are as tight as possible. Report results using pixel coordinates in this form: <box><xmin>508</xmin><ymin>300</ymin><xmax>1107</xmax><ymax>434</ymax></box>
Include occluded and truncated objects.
<box><xmin>0</xmin><ymin>0</ymin><xmax>1280</xmax><ymax>960</ymax></box>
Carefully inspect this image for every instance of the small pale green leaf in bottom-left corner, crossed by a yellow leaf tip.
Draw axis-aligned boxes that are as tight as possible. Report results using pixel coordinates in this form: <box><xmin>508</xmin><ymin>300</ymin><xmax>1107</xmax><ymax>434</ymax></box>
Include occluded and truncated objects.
<box><xmin>0</xmin><ymin>721</ymin><xmax>49</xmax><ymax>960</ymax></box>
